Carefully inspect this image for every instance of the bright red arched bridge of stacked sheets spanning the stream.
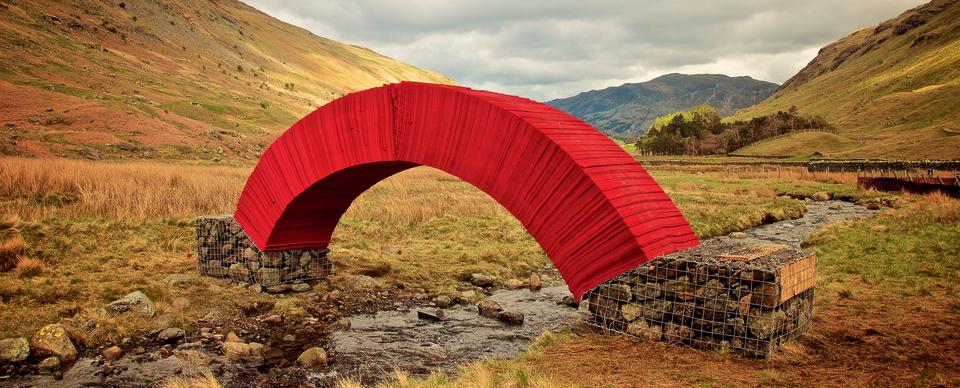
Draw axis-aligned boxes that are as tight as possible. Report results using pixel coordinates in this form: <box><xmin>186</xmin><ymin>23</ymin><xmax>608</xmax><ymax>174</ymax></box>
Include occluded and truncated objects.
<box><xmin>235</xmin><ymin>82</ymin><xmax>698</xmax><ymax>299</ymax></box>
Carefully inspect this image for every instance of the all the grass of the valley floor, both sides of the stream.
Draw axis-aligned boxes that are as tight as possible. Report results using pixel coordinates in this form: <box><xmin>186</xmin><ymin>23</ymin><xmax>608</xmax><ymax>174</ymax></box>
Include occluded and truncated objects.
<box><xmin>0</xmin><ymin>158</ymin><xmax>960</xmax><ymax>386</ymax></box>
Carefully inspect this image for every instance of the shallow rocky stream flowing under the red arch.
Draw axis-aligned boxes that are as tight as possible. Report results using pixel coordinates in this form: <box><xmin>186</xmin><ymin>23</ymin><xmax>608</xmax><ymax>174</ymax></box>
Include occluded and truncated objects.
<box><xmin>324</xmin><ymin>201</ymin><xmax>877</xmax><ymax>383</ymax></box>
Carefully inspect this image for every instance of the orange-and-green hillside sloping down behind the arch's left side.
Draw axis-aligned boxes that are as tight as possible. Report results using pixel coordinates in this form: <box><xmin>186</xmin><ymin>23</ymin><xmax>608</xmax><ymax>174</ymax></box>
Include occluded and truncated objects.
<box><xmin>0</xmin><ymin>0</ymin><xmax>452</xmax><ymax>160</ymax></box>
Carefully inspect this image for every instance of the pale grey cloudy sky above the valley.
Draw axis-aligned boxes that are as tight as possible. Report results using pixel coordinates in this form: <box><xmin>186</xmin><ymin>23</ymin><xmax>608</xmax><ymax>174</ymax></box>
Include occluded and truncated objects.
<box><xmin>246</xmin><ymin>0</ymin><xmax>923</xmax><ymax>100</ymax></box>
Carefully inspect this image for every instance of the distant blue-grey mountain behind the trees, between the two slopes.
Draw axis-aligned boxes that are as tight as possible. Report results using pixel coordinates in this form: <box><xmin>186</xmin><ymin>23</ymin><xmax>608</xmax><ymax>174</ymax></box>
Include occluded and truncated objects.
<box><xmin>547</xmin><ymin>74</ymin><xmax>777</xmax><ymax>139</ymax></box>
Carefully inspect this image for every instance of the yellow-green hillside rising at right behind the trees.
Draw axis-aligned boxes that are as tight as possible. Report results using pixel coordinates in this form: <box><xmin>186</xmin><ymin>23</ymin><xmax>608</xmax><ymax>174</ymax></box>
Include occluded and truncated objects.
<box><xmin>727</xmin><ymin>0</ymin><xmax>960</xmax><ymax>159</ymax></box>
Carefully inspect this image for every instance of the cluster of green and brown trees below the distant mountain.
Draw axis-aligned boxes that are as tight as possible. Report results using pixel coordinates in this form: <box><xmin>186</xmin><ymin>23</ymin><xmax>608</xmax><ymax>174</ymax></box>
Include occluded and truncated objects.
<box><xmin>637</xmin><ymin>104</ymin><xmax>831</xmax><ymax>155</ymax></box>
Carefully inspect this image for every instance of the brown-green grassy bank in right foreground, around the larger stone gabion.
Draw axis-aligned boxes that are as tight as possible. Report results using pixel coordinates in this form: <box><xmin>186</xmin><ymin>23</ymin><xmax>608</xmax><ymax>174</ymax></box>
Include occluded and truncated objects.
<box><xmin>358</xmin><ymin>192</ymin><xmax>960</xmax><ymax>387</ymax></box>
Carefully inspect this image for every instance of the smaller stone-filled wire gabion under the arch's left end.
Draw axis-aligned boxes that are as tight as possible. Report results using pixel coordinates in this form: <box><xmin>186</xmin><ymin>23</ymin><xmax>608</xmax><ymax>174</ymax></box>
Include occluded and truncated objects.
<box><xmin>197</xmin><ymin>215</ymin><xmax>331</xmax><ymax>287</ymax></box>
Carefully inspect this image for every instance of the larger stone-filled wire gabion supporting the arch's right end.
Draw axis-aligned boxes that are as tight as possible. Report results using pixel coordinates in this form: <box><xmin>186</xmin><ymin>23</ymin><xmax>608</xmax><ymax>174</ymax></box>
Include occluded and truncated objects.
<box><xmin>584</xmin><ymin>240</ymin><xmax>816</xmax><ymax>357</ymax></box>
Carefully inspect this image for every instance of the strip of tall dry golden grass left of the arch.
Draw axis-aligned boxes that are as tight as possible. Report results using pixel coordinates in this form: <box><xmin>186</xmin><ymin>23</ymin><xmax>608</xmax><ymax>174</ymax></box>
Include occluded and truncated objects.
<box><xmin>0</xmin><ymin>158</ymin><xmax>250</xmax><ymax>219</ymax></box>
